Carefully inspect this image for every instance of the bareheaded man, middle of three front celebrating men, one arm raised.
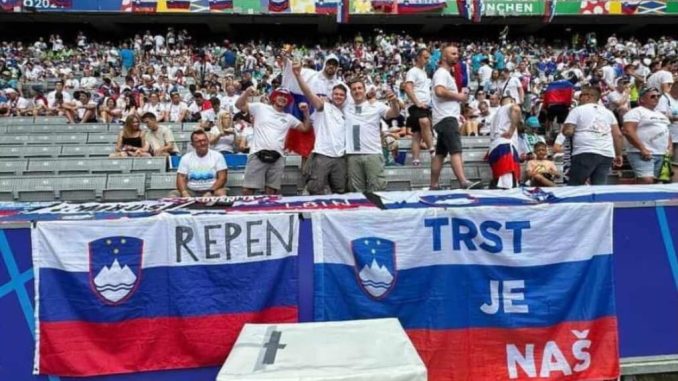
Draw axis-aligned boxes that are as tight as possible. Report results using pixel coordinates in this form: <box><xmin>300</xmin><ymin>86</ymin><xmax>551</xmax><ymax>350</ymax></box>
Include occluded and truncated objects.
<box><xmin>292</xmin><ymin>63</ymin><xmax>347</xmax><ymax>195</ymax></box>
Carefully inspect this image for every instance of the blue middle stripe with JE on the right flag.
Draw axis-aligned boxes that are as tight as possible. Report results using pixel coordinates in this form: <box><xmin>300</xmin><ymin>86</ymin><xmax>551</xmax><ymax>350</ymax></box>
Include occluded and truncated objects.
<box><xmin>315</xmin><ymin>255</ymin><xmax>615</xmax><ymax>329</ymax></box>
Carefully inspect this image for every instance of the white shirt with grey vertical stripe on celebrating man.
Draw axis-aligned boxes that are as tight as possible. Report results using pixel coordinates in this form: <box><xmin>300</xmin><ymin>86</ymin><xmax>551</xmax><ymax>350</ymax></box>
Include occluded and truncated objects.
<box><xmin>344</xmin><ymin>101</ymin><xmax>389</xmax><ymax>155</ymax></box>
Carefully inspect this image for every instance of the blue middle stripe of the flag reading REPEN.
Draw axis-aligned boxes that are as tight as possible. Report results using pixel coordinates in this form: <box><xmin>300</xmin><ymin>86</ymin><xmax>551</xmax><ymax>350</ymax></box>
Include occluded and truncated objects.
<box><xmin>40</xmin><ymin>257</ymin><xmax>297</xmax><ymax>322</ymax></box>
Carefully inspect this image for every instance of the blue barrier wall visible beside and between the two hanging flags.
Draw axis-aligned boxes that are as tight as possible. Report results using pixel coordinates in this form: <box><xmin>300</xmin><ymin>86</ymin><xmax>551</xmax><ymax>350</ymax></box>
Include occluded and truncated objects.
<box><xmin>0</xmin><ymin>202</ymin><xmax>678</xmax><ymax>381</ymax></box>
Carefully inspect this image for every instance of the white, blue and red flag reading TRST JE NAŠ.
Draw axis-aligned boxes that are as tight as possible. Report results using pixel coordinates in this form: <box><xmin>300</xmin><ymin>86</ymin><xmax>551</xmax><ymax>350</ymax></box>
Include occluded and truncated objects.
<box><xmin>312</xmin><ymin>204</ymin><xmax>619</xmax><ymax>381</ymax></box>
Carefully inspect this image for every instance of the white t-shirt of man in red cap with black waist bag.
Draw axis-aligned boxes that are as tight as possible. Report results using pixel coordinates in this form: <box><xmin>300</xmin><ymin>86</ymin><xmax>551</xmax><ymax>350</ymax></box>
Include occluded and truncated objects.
<box><xmin>248</xmin><ymin>103</ymin><xmax>301</xmax><ymax>155</ymax></box>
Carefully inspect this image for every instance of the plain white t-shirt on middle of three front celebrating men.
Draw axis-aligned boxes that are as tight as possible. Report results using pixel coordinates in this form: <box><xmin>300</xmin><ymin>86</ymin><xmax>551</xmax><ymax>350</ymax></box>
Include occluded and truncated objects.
<box><xmin>311</xmin><ymin>101</ymin><xmax>352</xmax><ymax>157</ymax></box>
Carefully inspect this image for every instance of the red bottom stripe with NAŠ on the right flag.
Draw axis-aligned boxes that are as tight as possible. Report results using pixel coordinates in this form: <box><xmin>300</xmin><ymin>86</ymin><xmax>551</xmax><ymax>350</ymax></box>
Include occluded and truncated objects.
<box><xmin>407</xmin><ymin>317</ymin><xmax>619</xmax><ymax>381</ymax></box>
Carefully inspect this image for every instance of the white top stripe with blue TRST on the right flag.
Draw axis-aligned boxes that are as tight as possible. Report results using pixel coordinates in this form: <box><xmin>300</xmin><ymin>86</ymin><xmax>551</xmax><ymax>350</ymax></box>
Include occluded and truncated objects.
<box><xmin>312</xmin><ymin>203</ymin><xmax>613</xmax><ymax>270</ymax></box>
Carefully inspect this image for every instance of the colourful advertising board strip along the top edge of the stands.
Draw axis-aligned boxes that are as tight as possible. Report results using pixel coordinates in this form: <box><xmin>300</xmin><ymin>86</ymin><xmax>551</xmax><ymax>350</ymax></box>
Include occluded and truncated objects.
<box><xmin>0</xmin><ymin>0</ymin><xmax>678</xmax><ymax>19</ymax></box>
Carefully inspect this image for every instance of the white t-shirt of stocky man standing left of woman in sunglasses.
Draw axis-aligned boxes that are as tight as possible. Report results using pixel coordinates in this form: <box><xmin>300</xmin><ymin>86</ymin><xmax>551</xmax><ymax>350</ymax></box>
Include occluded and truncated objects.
<box><xmin>565</xmin><ymin>103</ymin><xmax>617</xmax><ymax>158</ymax></box>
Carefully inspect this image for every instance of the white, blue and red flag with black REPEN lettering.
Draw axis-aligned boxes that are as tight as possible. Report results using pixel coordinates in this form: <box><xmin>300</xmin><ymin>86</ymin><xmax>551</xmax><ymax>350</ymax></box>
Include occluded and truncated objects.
<box><xmin>32</xmin><ymin>214</ymin><xmax>299</xmax><ymax>376</ymax></box>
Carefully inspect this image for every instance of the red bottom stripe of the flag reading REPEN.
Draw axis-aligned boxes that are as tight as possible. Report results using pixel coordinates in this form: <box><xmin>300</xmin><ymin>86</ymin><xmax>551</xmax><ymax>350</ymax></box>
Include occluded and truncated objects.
<box><xmin>40</xmin><ymin>307</ymin><xmax>298</xmax><ymax>376</ymax></box>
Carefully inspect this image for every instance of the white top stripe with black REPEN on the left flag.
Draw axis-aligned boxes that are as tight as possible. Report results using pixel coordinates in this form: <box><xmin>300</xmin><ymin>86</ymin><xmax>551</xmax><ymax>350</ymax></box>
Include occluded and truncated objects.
<box><xmin>31</xmin><ymin>214</ymin><xmax>299</xmax><ymax>272</ymax></box>
